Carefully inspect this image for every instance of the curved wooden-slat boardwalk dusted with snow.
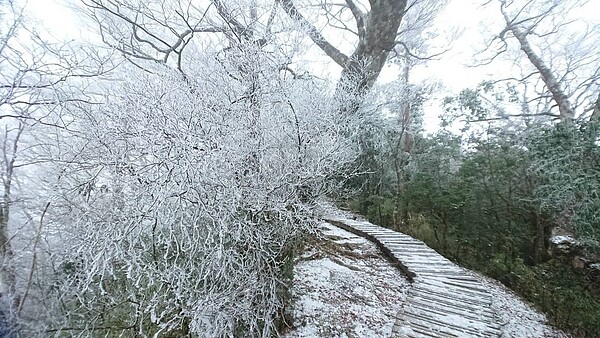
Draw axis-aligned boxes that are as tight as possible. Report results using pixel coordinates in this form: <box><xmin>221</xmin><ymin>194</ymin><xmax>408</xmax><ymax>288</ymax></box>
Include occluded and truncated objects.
<box><xmin>325</xmin><ymin>217</ymin><xmax>501</xmax><ymax>338</ymax></box>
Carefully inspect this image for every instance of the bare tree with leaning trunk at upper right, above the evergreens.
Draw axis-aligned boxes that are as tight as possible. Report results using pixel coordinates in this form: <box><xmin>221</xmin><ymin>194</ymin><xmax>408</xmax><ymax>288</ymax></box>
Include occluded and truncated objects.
<box><xmin>478</xmin><ymin>0</ymin><xmax>600</xmax><ymax>121</ymax></box>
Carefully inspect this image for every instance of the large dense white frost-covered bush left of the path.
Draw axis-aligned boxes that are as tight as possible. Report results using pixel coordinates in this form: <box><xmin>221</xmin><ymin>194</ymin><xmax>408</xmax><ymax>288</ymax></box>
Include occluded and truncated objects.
<box><xmin>39</xmin><ymin>53</ymin><xmax>350</xmax><ymax>337</ymax></box>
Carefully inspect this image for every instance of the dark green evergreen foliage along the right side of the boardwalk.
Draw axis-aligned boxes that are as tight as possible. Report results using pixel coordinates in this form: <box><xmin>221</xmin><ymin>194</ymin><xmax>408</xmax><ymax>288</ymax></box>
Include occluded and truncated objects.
<box><xmin>349</xmin><ymin>84</ymin><xmax>600</xmax><ymax>337</ymax></box>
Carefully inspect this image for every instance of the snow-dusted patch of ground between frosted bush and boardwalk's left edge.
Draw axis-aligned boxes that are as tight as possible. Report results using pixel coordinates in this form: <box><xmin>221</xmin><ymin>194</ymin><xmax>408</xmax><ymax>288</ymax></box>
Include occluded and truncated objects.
<box><xmin>285</xmin><ymin>224</ymin><xmax>410</xmax><ymax>338</ymax></box>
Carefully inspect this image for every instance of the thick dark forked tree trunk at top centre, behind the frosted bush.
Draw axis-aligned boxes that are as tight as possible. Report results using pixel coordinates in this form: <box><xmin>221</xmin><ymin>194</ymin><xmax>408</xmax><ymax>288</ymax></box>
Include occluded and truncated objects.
<box><xmin>279</xmin><ymin>0</ymin><xmax>408</xmax><ymax>114</ymax></box>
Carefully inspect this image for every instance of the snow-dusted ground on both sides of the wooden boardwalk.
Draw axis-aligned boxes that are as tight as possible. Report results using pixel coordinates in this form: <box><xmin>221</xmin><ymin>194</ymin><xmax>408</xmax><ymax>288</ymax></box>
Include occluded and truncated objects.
<box><xmin>286</xmin><ymin>218</ymin><xmax>568</xmax><ymax>338</ymax></box>
